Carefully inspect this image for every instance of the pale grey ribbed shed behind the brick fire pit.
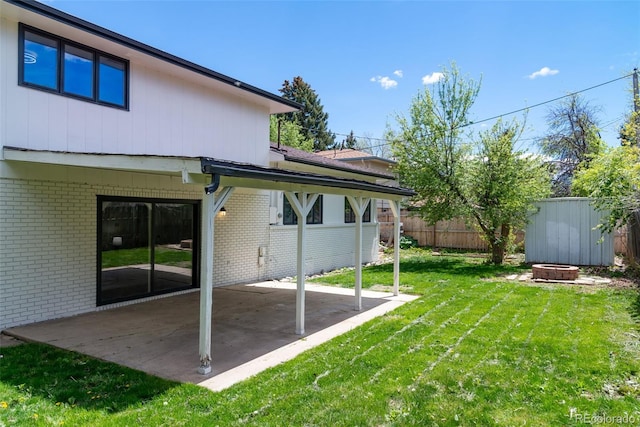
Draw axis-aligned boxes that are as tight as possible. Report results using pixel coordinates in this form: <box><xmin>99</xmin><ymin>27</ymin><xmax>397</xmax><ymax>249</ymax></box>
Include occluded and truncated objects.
<box><xmin>525</xmin><ymin>198</ymin><xmax>614</xmax><ymax>265</ymax></box>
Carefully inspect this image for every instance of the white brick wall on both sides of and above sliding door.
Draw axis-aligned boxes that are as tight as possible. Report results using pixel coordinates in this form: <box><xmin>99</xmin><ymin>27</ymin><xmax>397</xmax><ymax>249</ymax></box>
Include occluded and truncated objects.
<box><xmin>0</xmin><ymin>168</ymin><xmax>269</xmax><ymax>330</ymax></box>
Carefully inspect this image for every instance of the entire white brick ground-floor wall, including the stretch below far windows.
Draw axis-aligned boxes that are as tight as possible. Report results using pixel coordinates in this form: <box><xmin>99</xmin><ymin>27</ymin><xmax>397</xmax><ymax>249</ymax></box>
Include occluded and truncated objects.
<box><xmin>0</xmin><ymin>166</ymin><xmax>377</xmax><ymax>330</ymax></box>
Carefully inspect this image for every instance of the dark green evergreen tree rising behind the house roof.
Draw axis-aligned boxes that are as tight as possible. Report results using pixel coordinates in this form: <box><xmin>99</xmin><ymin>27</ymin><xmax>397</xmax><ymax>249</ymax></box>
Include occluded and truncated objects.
<box><xmin>280</xmin><ymin>76</ymin><xmax>335</xmax><ymax>151</ymax></box>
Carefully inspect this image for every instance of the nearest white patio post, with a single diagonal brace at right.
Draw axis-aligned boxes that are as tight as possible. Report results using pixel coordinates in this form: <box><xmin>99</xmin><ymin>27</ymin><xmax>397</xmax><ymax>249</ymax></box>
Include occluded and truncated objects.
<box><xmin>198</xmin><ymin>187</ymin><xmax>234</xmax><ymax>375</ymax></box>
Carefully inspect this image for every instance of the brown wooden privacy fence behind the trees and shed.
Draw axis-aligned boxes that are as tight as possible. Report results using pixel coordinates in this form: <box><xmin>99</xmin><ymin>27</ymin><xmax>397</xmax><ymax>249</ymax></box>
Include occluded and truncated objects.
<box><xmin>378</xmin><ymin>210</ymin><xmax>627</xmax><ymax>254</ymax></box>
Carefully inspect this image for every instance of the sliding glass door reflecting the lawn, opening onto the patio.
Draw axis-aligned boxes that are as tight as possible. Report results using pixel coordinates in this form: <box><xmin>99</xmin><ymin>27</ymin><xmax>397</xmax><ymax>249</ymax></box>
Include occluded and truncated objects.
<box><xmin>97</xmin><ymin>196</ymin><xmax>199</xmax><ymax>305</ymax></box>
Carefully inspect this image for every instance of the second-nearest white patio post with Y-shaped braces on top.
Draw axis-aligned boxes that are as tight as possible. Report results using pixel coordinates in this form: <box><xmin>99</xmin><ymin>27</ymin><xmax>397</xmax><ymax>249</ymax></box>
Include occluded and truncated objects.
<box><xmin>284</xmin><ymin>191</ymin><xmax>319</xmax><ymax>335</ymax></box>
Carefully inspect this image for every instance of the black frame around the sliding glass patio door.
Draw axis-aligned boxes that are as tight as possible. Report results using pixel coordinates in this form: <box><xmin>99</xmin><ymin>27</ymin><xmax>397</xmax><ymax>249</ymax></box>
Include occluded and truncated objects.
<box><xmin>96</xmin><ymin>195</ymin><xmax>202</xmax><ymax>306</ymax></box>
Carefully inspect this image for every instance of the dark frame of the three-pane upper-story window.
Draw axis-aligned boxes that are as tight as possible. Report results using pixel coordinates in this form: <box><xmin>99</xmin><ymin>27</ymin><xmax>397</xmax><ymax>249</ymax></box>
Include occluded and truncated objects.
<box><xmin>18</xmin><ymin>22</ymin><xmax>130</xmax><ymax>111</ymax></box>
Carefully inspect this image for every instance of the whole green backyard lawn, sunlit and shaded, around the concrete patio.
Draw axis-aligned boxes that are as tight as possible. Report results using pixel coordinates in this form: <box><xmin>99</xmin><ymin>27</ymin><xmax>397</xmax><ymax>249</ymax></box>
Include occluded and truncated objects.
<box><xmin>0</xmin><ymin>251</ymin><xmax>640</xmax><ymax>426</ymax></box>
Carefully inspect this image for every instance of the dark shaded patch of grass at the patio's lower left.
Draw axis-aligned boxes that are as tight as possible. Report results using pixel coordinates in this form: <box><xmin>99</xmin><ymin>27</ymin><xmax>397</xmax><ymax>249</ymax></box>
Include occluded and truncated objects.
<box><xmin>0</xmin><ymin>343</ymin><xmax>180</xmax><ymax>413</ymax></box>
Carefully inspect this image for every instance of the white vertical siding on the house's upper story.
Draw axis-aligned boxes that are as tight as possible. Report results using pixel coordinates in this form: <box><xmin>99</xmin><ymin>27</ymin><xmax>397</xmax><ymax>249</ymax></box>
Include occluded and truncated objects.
<box><xmin>0</xmin><ymin>19</ymin><xmax>269</xmax><ymax>166</ymax></box>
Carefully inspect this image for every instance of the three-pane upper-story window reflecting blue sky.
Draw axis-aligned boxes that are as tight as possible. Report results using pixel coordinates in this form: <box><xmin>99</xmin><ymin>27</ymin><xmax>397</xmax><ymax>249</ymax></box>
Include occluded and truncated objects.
<box><xmin>19</xmin><ymin>24</ymin><xmax>129</xmax><ymax>109</ymax></box>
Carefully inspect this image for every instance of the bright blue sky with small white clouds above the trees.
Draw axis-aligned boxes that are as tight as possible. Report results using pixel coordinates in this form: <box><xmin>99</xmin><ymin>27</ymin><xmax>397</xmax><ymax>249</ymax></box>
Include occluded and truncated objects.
<box><xmin>46</xmin><ymin>0</ymin><xmax>640</xmax><ymax>150</ymax></box>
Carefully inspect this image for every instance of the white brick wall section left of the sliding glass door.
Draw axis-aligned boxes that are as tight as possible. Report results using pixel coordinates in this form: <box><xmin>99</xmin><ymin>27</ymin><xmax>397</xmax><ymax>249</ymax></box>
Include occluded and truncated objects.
<box><xmin>0</xmin><ymin>179</ymin><xmax>96</xmax><ymax>328</ymax></box>
